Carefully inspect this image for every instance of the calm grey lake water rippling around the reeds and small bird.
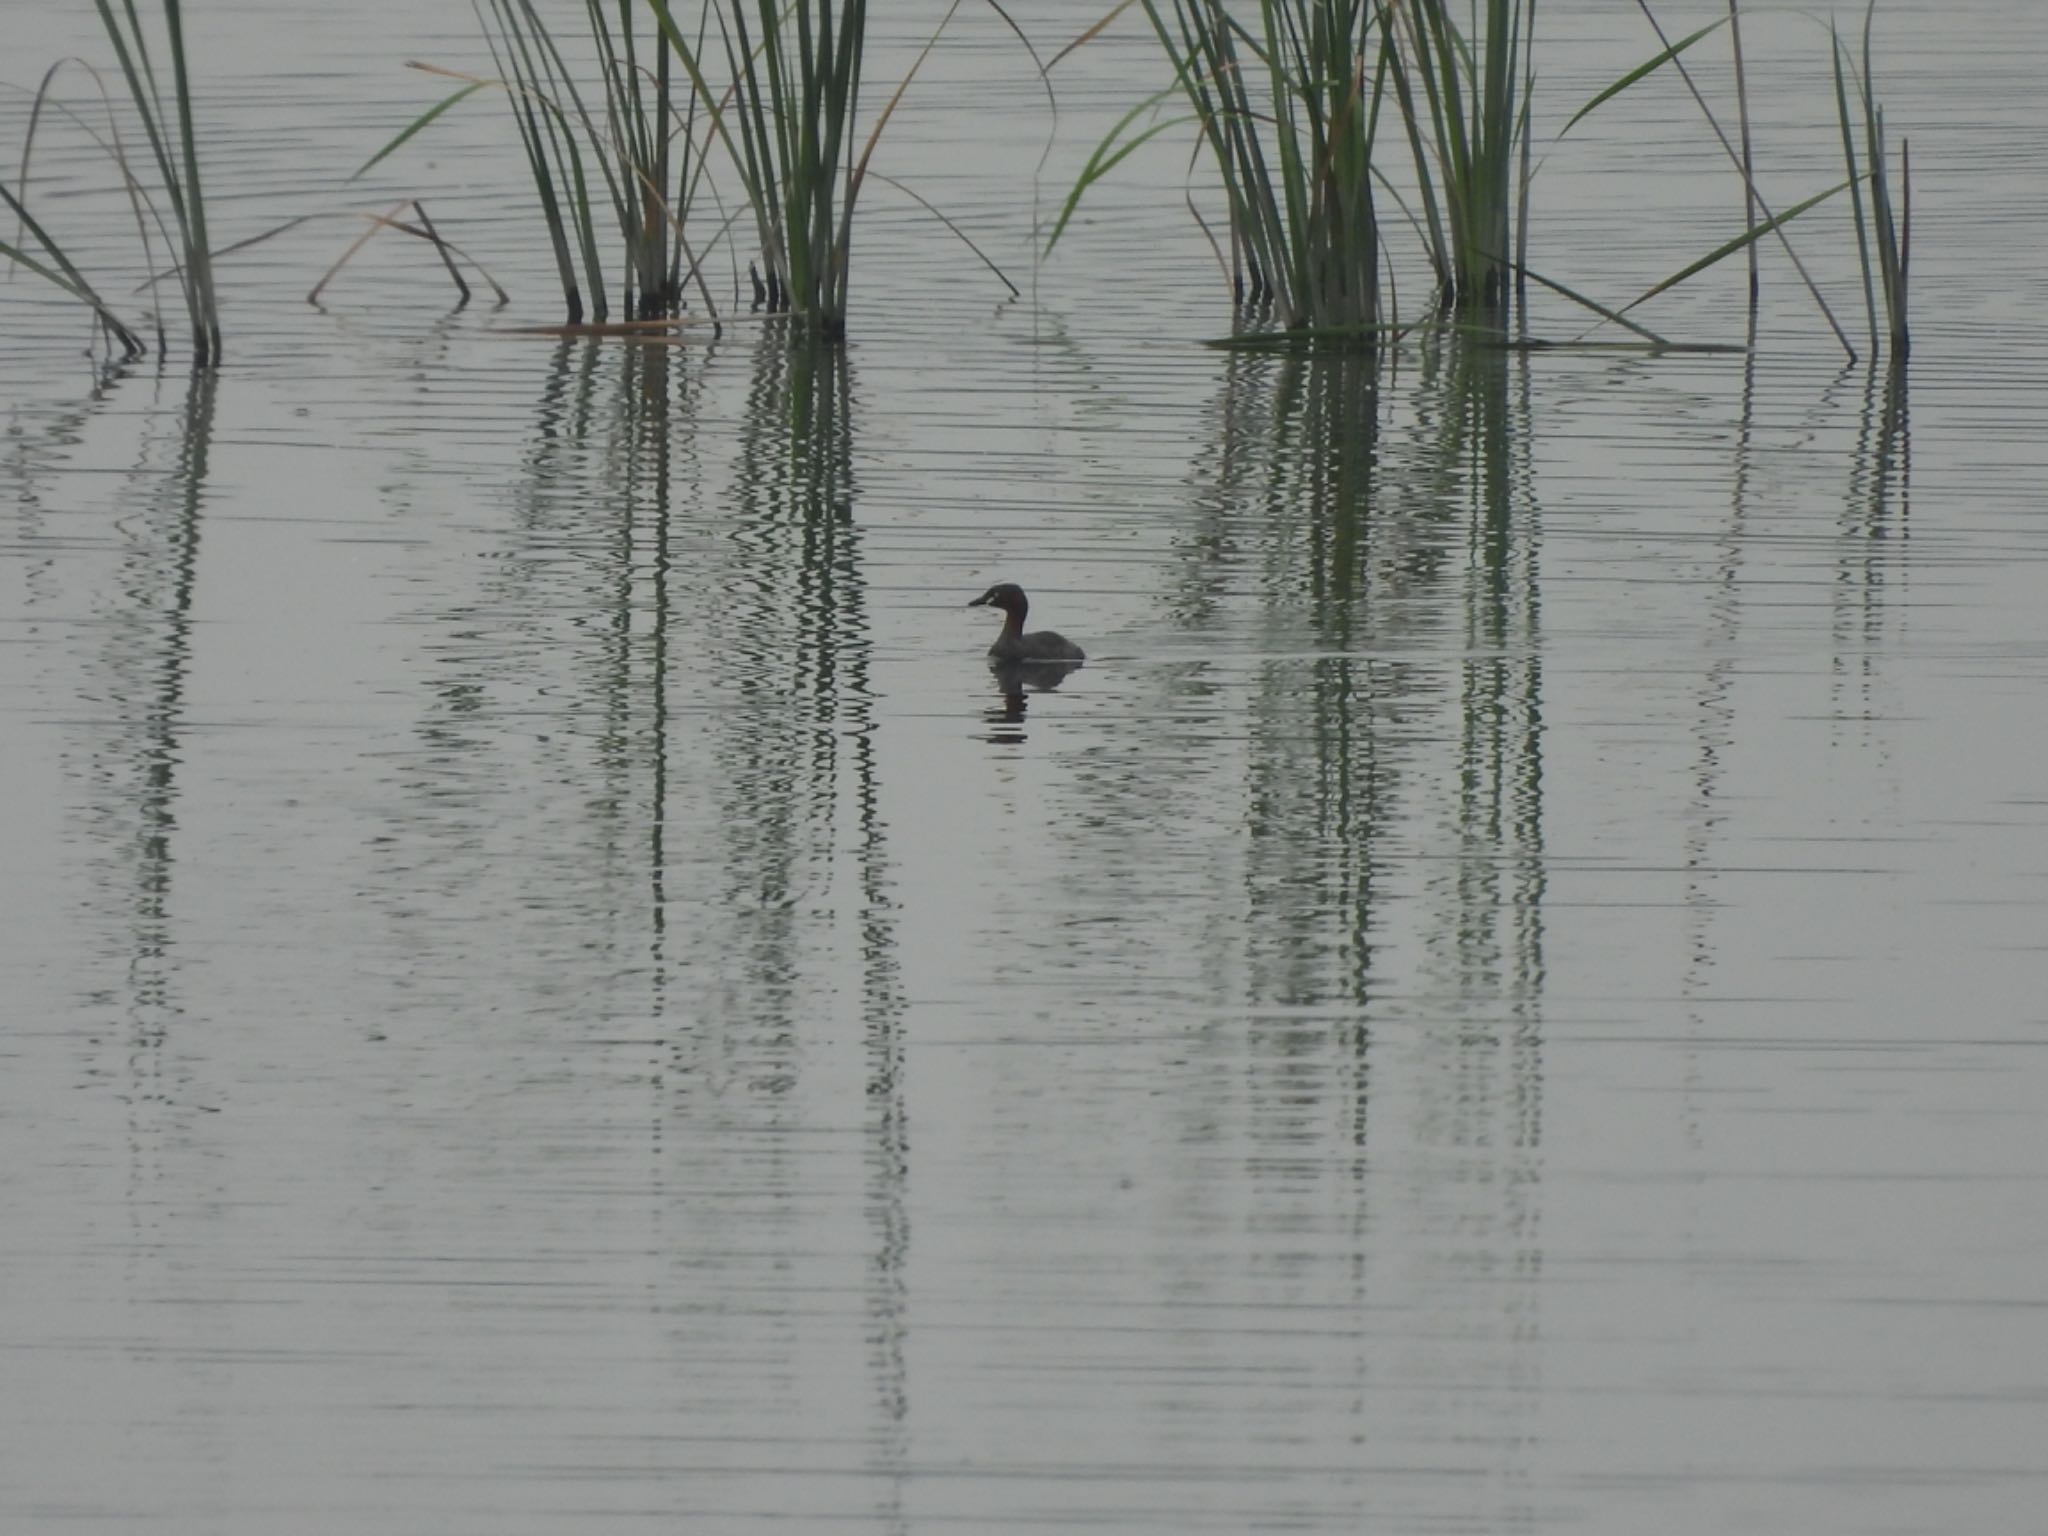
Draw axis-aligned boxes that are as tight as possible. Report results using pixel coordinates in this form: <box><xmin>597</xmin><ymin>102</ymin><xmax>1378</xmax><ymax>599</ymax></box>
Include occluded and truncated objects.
<box><xmin>0</xmin><ymin>0</ymin><xmax>2048</xmax><ymax>1536</ymax></box>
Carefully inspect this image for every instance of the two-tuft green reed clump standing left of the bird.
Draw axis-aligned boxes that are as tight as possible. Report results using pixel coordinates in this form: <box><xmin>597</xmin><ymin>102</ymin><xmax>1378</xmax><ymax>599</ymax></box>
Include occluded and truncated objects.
<box><xmin>395</xmin><ymin>0</ymin><xmax>962</xmax><ymax>340</ymax></box>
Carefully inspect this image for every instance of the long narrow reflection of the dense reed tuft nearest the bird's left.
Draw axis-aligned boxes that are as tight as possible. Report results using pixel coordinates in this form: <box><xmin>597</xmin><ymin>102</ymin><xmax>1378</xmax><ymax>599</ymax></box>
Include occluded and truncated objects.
<box><xmin>720</xmin><ymin>324</ymin><xmax>911</xmax><ymax>1530</ymax></box>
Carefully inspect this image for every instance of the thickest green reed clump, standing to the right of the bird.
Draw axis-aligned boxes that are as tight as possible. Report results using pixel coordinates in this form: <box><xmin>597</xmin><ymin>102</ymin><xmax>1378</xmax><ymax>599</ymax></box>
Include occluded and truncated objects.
<box><xmin>1049</xmin><ymin>0</ymin><xmax>1536</xmax><ymax>330</ymax></box>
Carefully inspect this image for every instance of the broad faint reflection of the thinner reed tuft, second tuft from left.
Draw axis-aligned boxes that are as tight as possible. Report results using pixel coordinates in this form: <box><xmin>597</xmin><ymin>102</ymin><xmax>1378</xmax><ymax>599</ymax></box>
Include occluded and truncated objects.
<box><xmin>377</xmin><ymin>340</ymin><xmax>709</xmax><ymax>1048</ymax></box>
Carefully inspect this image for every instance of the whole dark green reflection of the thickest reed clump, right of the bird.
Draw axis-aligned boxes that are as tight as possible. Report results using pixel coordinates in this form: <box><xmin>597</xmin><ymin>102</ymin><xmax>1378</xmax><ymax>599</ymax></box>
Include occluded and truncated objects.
<box><xmin>1153</xmin><ymin>344</ymin><xmax>1544</xmax><ymax>1528</ymax></box>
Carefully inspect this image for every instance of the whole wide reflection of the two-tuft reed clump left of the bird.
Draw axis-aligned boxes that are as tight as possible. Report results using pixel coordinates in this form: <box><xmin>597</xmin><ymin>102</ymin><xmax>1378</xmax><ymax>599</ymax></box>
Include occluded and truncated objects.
<box><xmin>383</xmin><ymin>332</ymin><xmax>909</xmax><ymax>1497</ymax></box>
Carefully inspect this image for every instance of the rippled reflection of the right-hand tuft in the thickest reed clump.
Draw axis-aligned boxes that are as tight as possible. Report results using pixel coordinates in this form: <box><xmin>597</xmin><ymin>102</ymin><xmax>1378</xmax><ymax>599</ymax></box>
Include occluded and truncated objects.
<box><xmin>1368</xmin><ymin>344</ymin><xmax>1548</xmax><ymax>1528</ymax></box>
